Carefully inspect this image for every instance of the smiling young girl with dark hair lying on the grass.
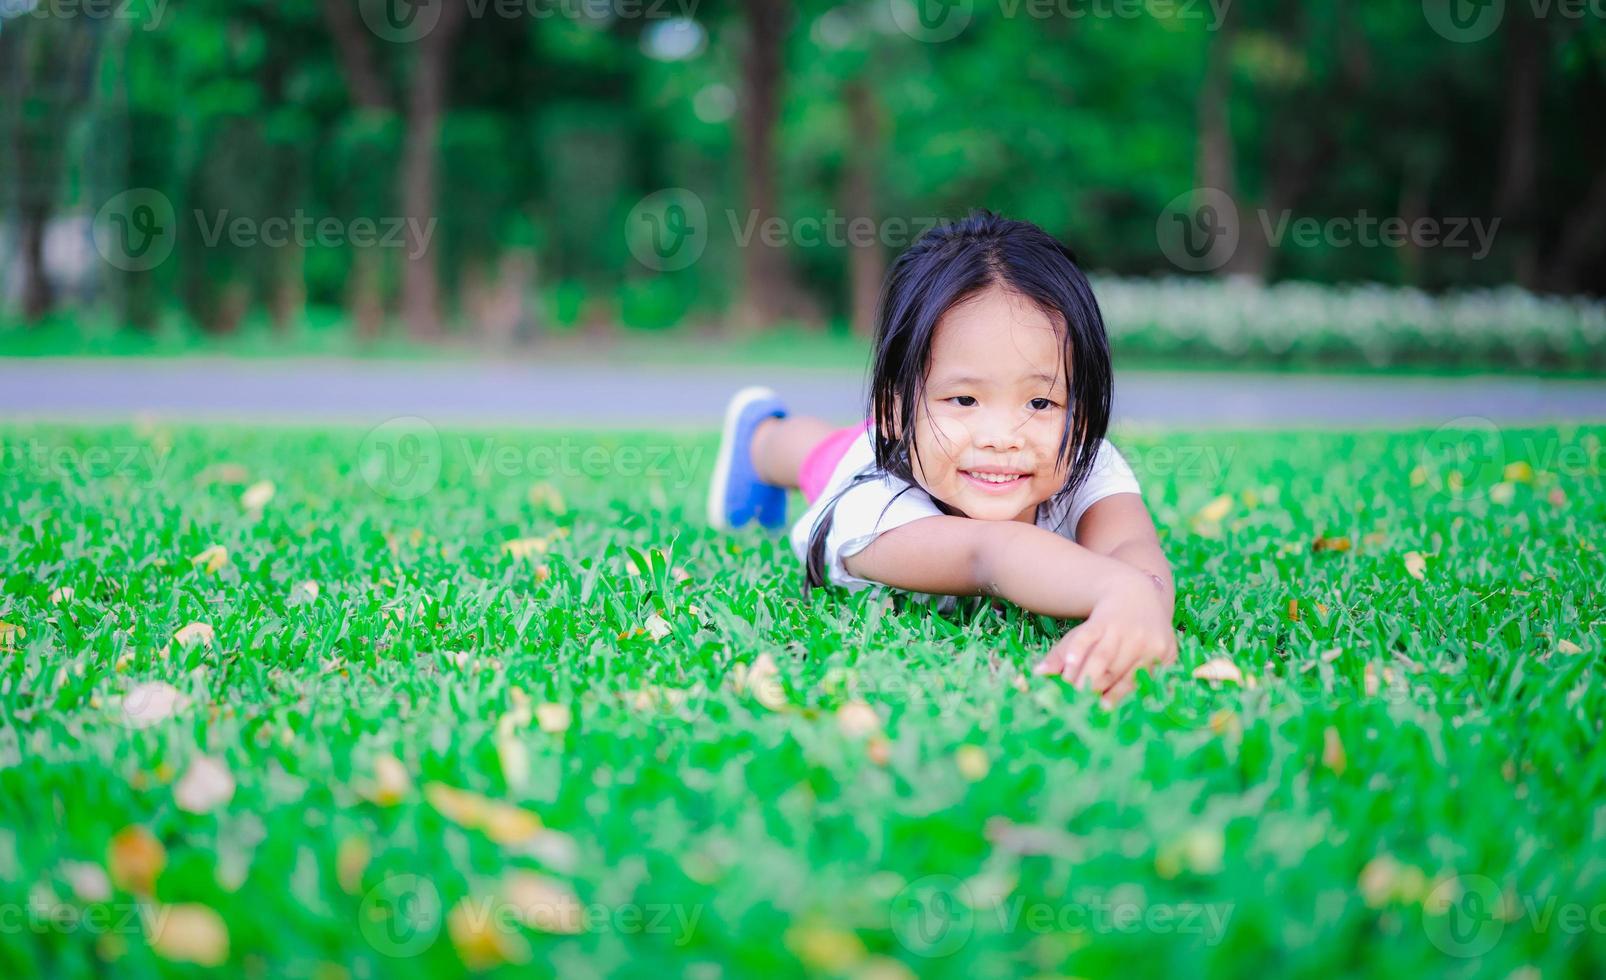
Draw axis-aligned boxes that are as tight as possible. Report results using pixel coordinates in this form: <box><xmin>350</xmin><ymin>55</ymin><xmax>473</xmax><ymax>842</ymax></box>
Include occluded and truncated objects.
<box><xmin>708</xmin><ymin>212</ymin><xmax>1177</xmax><ymax>704</ymax></box>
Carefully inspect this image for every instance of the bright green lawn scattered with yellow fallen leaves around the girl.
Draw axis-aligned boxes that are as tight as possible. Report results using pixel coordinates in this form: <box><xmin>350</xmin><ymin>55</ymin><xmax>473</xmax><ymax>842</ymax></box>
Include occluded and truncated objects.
<box><xmin>0</xmin><ymin>423</ymin><xmax>1606</xmax><ymax>977</ymax></box>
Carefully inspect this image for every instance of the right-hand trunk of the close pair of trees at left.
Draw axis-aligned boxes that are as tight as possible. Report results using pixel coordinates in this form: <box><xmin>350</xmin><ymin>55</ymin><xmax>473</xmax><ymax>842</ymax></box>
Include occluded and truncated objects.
<box><xmin>402</xmin><ymin>0</ymin><xmax>467</xmax><ymax>341</ymax></box>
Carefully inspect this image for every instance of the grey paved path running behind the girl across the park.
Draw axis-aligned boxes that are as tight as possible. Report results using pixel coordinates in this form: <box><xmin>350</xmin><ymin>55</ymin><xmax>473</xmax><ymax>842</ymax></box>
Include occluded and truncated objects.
<box><xmin>0</xmin><ymin>358</ymin><xmax>1606</xmax><ymax>427</ymax></box>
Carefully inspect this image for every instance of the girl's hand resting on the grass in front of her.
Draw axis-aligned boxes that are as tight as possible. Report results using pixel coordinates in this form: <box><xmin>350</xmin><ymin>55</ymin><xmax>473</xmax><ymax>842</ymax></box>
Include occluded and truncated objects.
<box><xmin>1033</xmin><ymin>574</ymin><xmax>1177</xmax><ymax>705</ymax></box>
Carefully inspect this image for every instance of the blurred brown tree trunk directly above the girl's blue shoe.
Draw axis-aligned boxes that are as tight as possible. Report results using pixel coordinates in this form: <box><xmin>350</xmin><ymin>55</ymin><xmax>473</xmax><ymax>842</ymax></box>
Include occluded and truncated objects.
<box><xmin>737</xmin><ymin>0</ymin><xmax>801</xmax><ymax>331</ymax></box>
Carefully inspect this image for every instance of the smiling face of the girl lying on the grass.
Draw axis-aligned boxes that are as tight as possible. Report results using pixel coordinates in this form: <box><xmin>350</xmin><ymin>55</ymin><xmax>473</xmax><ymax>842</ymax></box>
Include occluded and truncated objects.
<box><xmin>912</xmin><ymin>286</ymin><xmax>1070</xmax><ymax>522</ymax></box>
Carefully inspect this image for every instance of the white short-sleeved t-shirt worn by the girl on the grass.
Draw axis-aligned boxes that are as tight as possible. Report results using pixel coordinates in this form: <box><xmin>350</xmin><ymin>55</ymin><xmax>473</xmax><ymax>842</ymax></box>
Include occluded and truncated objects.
<box><xmin>792</xmin><ymin>432</ymin><xmax>1142</xmax><ymax>591</ymax></box>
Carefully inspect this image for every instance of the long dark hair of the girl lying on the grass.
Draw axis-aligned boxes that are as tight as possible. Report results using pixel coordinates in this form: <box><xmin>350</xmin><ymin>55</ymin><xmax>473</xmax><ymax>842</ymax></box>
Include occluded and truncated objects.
<box><xmin>806</xmin><ymin>210</ymin><xmax>1115</xmax><ymax>588</ymax></box>
